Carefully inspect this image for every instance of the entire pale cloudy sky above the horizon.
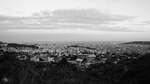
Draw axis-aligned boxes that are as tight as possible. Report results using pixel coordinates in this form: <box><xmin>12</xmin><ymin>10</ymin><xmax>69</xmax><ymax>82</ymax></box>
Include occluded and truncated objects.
<box><xmin>0</xmin><ymin>0</ymin><xmax>150</xmax><ymax>42</ymax></box>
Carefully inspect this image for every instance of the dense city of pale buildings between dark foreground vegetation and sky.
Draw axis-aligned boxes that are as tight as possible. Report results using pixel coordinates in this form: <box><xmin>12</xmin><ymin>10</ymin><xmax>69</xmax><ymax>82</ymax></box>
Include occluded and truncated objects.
<box><xmin>1</xmin><ymin>43</ymin><xmax>150</xmax><ymax>66</ymax></box>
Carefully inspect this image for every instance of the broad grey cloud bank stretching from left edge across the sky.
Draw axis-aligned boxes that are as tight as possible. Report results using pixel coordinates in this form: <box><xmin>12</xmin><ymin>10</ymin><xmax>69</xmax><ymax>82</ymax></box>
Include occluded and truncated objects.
<box><xmin>0</xmin><ymin>9</ymin><xmax>135</xmax><ymax>31</ymax></box>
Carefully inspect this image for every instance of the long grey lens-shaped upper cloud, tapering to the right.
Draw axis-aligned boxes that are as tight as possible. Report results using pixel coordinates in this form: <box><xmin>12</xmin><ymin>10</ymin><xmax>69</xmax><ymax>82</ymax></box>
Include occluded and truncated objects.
<box><xmin>31</xmin><ymin>9</ymin><xmax>133</xmax><ymax>24</ymax></box>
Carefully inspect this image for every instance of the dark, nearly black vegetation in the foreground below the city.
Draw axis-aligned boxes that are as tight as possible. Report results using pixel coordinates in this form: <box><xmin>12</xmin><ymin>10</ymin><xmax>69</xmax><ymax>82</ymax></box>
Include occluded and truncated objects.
<box><xmin>0</xmin><ymin>52</ymin><xmax>150</xmax><ymax>84</ymax></box>
